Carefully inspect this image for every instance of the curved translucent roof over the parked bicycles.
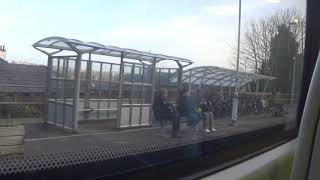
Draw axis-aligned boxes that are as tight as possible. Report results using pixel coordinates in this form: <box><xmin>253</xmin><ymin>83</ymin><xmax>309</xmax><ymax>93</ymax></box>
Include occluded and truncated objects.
<box><xmin>171</xmin><ymin>66</ymin><xmax>275</xmax><ymax>87</ymax></box>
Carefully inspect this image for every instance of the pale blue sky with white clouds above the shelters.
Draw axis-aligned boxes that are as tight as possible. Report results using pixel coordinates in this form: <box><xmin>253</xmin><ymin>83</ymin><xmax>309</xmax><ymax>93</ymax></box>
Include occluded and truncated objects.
<box><xmin>0</xmin><ymin>0</ymin><xmax>305</xmax><ymax>68</ymax></box>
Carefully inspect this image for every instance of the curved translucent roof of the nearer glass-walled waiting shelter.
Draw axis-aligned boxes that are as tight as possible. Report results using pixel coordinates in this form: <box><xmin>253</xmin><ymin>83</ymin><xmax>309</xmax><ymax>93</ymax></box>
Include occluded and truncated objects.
<box><xmin>33</xmin><ymin>36</ymin><xmax>193</xmax><ymax>65</ymax></box>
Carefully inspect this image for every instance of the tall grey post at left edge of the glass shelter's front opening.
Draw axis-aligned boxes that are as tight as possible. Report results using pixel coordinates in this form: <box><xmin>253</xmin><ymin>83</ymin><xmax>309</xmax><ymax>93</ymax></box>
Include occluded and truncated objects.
<box><xmin>72</xmin><ymin>54</ymin><xmax>81</xmax><ymax>132</ymax></box>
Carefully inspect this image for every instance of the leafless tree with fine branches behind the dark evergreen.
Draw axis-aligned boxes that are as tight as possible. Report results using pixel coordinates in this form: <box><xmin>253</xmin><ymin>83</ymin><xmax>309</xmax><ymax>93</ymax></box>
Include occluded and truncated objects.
<box><xmin>231</xmin><ymin>9</ymin><xmax>304</xmax><ymax>75</ymax></box>
